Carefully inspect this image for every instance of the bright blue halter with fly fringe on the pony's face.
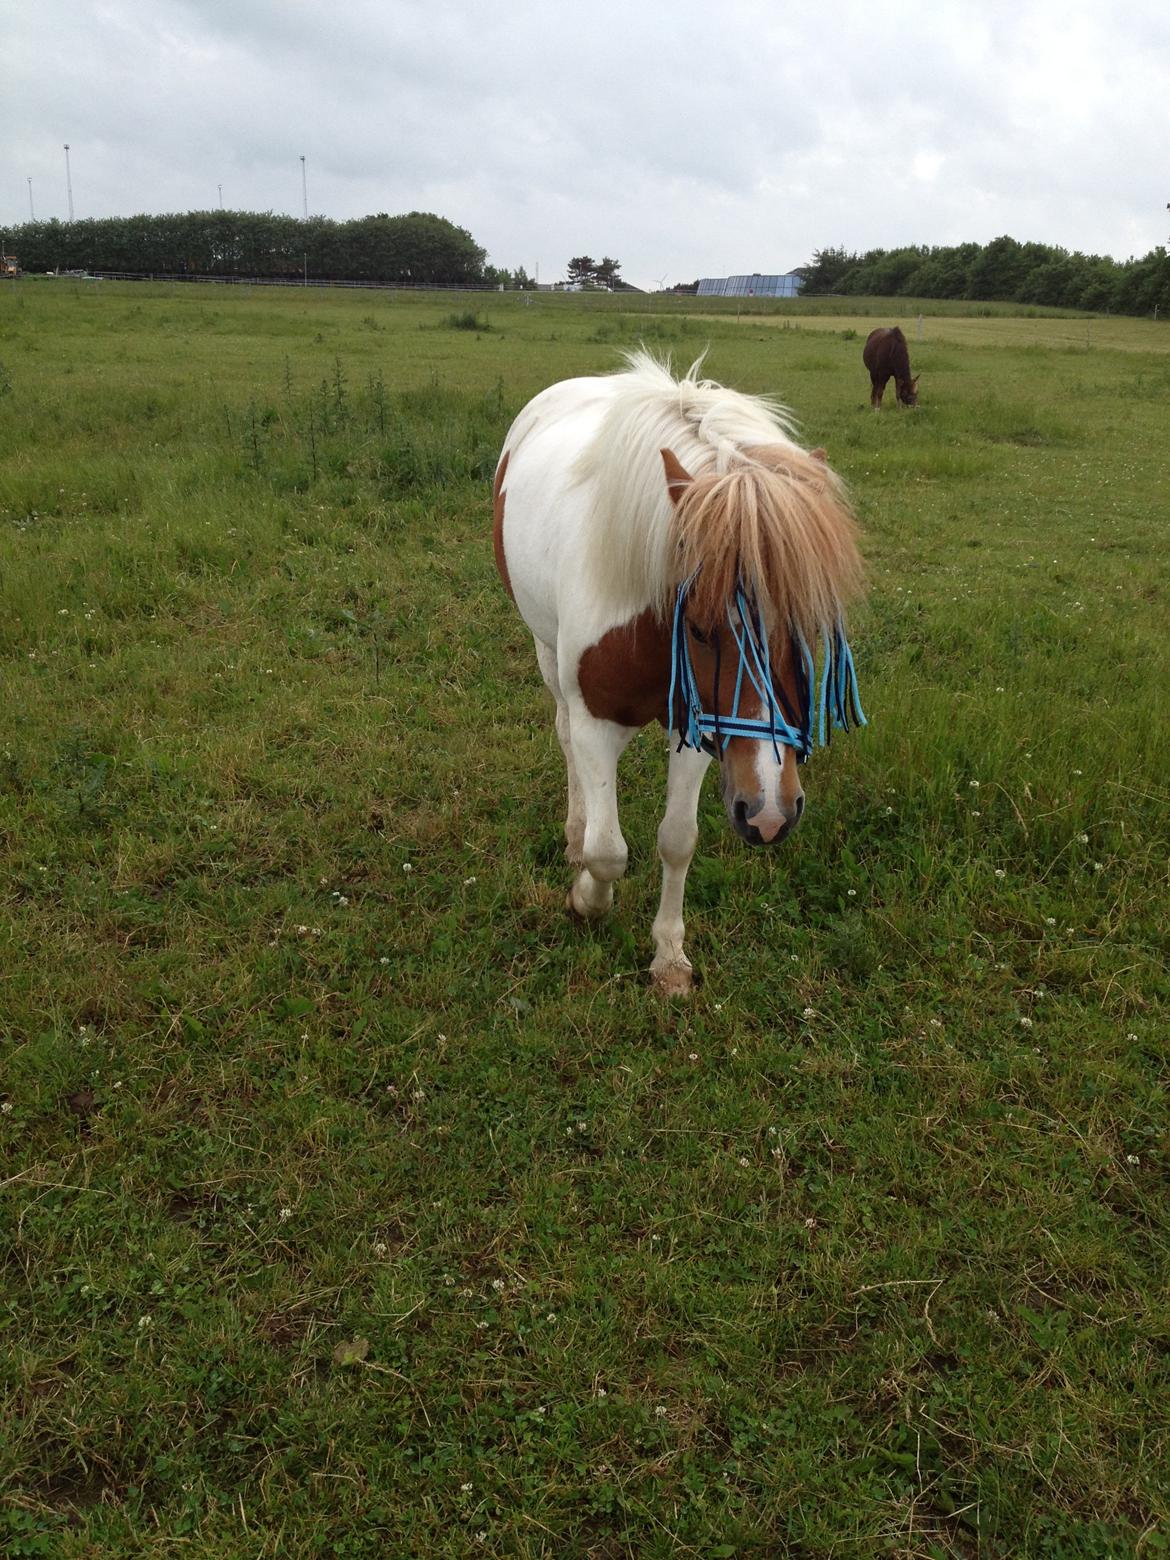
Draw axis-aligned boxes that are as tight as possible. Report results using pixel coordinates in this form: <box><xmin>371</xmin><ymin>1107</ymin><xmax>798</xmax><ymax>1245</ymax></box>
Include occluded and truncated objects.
<box><xmin>666</xmin><ymin>571</ymin><xmax>866</xmax><ymax>763</ymax></box>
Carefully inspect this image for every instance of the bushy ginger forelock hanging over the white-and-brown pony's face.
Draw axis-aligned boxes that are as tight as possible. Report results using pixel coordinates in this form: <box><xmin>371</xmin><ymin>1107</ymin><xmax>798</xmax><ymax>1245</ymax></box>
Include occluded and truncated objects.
<box><xmin>674</xmin><ymin>445</ymin><xmax>861</xmax><ymax>644</ymax></box>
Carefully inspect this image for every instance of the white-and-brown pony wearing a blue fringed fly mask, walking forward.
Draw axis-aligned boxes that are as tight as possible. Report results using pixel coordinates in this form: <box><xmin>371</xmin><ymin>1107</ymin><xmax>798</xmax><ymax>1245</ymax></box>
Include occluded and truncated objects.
<box><xmin>495</xmin><ymin>353</ymin><xmax>864</xmax><ymax>992</ymax></box>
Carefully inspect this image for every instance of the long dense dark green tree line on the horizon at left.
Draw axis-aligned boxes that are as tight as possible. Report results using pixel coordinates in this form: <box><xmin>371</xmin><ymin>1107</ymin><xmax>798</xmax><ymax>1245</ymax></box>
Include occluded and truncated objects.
<box><xmin>3</xmin><ymin>211</ymin><xmax>530</xmax><ymax>287</ymax></box>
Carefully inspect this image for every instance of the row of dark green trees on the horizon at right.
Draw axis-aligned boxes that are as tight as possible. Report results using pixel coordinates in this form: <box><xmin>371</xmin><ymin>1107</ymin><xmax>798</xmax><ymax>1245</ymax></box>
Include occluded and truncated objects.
<box><xmin>803</xmin><ymin>237</ymin><xmax>1170</xmax><ymax>314</ymax></box>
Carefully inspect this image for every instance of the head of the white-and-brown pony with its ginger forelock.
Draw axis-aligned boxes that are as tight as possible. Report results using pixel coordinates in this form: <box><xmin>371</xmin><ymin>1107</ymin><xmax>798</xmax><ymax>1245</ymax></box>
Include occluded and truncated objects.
<box><xmin>661</xmin><ymin>445</ymin><xmax>861</xmax><ymax>846</ymax></box>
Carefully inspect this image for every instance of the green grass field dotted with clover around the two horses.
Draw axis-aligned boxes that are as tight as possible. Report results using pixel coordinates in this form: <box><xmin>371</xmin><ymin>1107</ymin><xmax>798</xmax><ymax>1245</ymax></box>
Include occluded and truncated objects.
<box><xmin>0</xmin><ymin>278</ymin><xmax>1170</xmax><ymax>1560</ymax></box>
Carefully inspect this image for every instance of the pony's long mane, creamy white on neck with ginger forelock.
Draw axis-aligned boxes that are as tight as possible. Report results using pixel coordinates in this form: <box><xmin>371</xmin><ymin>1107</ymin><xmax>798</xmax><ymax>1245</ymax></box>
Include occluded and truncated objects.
<box><xmin>576</xmin><ymin>349</ymin><xmax>861</xmax><ymax>644</ymax></box>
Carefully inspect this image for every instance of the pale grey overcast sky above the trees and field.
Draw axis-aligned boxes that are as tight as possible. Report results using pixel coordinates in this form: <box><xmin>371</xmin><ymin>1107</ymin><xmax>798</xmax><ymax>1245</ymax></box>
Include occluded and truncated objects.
<box><xmin>0</xmin><ymin>0</ymin><xmax>1170</xmax><ymax>287</ymax></box>
